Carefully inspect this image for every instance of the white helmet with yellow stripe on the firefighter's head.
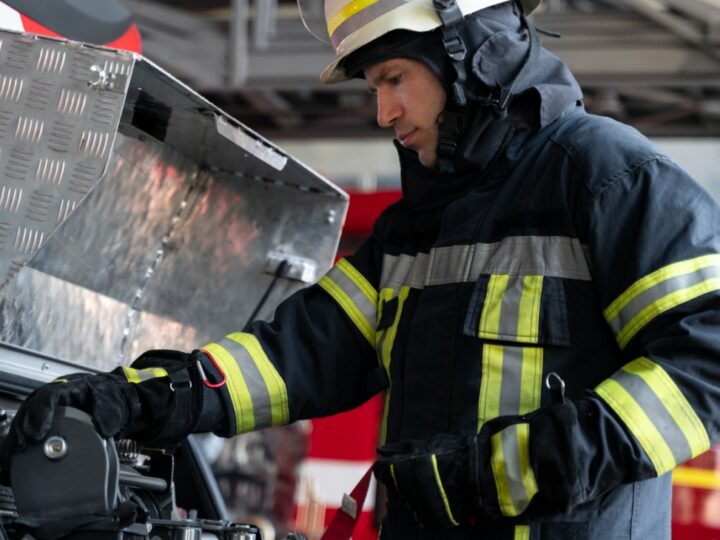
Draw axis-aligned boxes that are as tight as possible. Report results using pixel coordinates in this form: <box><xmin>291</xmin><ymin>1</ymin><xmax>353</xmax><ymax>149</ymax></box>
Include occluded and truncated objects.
<box><xmin>298</xmin><ymin>0</ymin><xmax>540</xmax><ymax>84</ymax></box>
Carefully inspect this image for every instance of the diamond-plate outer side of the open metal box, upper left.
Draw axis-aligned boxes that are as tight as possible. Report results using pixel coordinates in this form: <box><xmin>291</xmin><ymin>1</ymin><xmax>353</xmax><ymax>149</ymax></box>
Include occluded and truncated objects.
<box><xmin>0</xmin><ymin>33</ymin><xmax>134</xmax><ymax>286</ymax></box>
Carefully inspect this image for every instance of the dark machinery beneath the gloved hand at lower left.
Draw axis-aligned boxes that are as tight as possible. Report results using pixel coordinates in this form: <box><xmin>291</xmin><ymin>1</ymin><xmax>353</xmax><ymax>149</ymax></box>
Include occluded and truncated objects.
<box><xmin>0</xmin><ymin>408</ymin><xmax>270</xmax><ymax>540</ymax></box>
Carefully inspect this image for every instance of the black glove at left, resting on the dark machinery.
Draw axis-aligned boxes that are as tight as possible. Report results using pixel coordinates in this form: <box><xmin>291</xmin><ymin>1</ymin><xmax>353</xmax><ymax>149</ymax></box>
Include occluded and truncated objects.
<box><xmin>0</xmin><ymin>350</ymin><xmax>222</xmax><ymax>469</ymax></box>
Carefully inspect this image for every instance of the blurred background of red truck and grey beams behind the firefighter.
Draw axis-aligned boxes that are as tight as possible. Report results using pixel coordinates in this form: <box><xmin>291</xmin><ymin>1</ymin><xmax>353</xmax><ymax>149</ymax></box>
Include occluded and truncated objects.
<box><xmin>0</xmin><ymin>0</ymin><xmax>720</xmax><ymax>540</ymax></box>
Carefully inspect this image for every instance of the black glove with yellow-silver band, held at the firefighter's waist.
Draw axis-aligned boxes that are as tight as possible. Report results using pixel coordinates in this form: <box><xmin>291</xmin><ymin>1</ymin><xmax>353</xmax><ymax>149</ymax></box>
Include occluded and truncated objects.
<box><xmin>374</xmin><ymin>402</ymin><xmax>578</xmax><ymax>529</ymax></box>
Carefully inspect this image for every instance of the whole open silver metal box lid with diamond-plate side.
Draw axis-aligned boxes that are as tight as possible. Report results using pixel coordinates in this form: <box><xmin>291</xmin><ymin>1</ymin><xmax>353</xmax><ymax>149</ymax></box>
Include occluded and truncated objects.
<box><xmin>0</xmin><ymin>31</ymin><xmax>347</xmax><ymax>376</ymax></box>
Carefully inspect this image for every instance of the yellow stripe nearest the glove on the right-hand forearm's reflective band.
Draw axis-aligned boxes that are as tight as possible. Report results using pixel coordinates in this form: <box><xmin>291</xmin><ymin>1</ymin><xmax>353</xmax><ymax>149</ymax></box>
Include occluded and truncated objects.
<box><xmin>595</xmin><ymin>379</ymin><xmax>677</xmax><ymax>476</ymax></box>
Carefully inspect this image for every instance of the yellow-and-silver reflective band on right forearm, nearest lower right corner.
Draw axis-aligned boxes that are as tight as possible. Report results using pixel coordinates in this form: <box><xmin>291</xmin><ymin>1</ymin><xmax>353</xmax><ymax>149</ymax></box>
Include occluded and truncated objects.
<box><xmin>595</xmin><ymin>358</ymin><xmax>710</xmax><ymax>476</ymax></box>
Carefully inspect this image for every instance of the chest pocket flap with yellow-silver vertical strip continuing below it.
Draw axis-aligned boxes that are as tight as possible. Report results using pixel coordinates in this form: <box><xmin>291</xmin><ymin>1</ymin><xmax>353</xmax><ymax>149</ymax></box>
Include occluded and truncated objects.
<box><xmin>463</xmin><ymin>274</ymin><xmax>570</xmax><ymax>431</ymax></box>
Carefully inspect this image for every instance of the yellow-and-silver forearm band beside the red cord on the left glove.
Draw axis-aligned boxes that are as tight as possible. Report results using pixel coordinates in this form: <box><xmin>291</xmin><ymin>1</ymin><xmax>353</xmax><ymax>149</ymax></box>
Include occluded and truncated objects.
<box><xmin>203</xmin><ymin>333</ymin><xmax>290</xmax><ymax>433</ymax></box>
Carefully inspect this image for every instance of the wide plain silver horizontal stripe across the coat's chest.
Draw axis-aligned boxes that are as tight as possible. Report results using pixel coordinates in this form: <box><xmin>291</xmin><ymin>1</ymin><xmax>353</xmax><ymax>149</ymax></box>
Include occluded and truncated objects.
<box><xmin>380</xmin><ymin>236</ymin><xmax>591</xmax><ymax>289</ymax></box>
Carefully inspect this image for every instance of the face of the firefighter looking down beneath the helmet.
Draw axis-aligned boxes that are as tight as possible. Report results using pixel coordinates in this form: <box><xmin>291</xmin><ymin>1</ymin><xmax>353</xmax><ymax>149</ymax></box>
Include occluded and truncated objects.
<box><xmin>365</xmin><ymin>58</ymin><xmax>447</xmax><ymax>167</ymax></box>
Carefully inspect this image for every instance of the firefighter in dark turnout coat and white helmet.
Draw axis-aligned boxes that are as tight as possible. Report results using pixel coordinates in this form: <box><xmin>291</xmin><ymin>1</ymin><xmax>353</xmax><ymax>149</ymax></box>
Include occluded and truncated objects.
<box><xmin>5</xmin><ymin>0</ymin><xmax>720</xmax><ymax>540</ymax></box>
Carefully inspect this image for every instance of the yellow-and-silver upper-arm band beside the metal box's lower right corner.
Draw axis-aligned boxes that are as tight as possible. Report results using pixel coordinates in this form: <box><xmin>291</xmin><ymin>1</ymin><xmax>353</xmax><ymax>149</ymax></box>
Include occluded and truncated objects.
<box><xmin>318</xmin><ymin>259</ymin><xmax>378</xmax><ymax>347</ymax></box>
